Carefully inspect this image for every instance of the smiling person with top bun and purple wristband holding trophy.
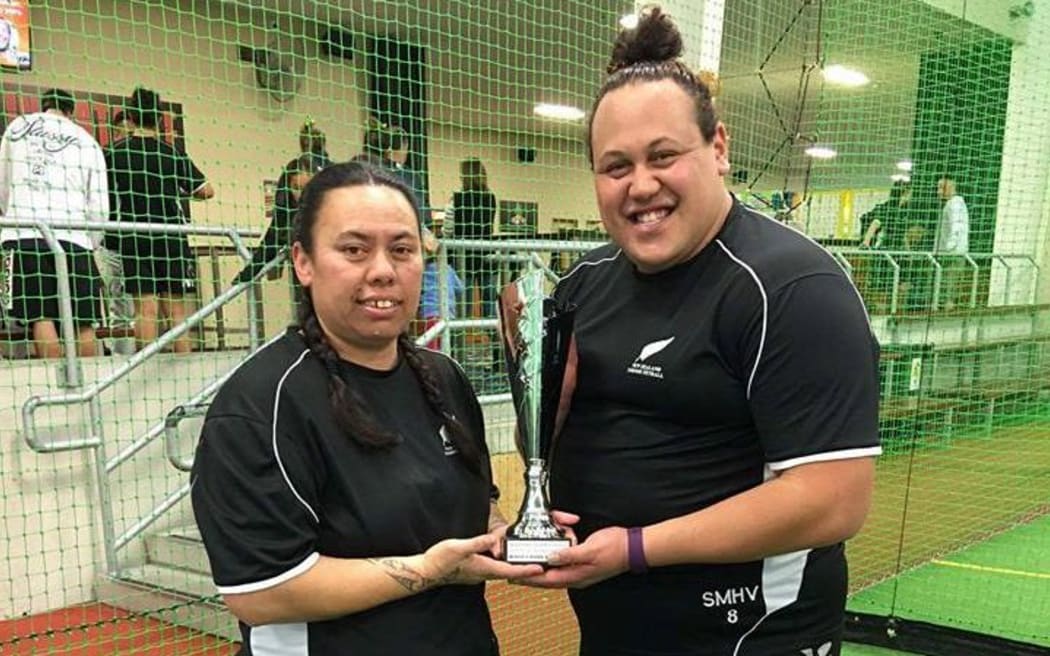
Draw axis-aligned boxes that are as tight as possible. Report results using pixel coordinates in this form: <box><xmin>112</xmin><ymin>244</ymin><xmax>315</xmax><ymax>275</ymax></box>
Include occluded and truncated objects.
<box><xmin>528</xmin><ymin>7</ymin><xmax>880</xmax><ymax>656</ymax></box>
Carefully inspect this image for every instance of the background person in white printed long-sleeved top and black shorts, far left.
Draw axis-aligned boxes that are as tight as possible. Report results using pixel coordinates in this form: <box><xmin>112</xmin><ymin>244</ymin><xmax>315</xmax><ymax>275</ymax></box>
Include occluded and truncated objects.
<box><xmin>0</xmin><ymin>89</ymin><xmax>109</xmax><ymax>358</ymax></box>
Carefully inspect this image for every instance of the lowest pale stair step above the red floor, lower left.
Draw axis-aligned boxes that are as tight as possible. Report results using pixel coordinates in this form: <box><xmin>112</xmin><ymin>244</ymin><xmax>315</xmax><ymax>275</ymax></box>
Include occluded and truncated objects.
<box><xmin>97</xmin><ymin>565</ymin><xmax>240</xmax><ymax>641</ymax></box>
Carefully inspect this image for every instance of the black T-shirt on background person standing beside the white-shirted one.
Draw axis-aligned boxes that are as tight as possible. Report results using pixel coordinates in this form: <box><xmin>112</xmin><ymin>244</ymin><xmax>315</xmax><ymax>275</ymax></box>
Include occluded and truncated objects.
<box><xmin>106</xmin><ymin>136</ymin><xmax>206</xmax><ymax>257</ymax></box>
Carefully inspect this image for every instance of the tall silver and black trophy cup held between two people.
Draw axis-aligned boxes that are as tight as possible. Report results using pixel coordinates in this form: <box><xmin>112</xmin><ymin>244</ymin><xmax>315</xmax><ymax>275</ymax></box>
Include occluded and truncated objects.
<box><xmin>499</xmin><ymin>269</ymin><xmax>574</xmax><ymax>564</ymax></box>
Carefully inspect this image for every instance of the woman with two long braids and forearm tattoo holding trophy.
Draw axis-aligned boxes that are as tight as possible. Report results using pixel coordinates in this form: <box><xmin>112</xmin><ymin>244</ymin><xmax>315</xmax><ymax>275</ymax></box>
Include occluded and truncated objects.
<box><xmin>191</xmin><ymin>163</ymin><xmax>541</xmax><ymax>656</ymax></box>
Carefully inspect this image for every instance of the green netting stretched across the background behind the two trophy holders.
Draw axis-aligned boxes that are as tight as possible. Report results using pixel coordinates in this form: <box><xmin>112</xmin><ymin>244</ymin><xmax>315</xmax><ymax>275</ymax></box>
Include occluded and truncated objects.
<box><xmin>0</xmin><ymin>0</ymin><xmax>1050</xmax><ymax>655</ymax></box>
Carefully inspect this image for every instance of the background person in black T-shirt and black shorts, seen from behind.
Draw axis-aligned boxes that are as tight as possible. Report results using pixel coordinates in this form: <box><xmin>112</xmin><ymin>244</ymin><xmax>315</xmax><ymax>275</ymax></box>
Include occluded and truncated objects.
<box><xmin>106</xmin><ymin>88</ymin><xmax>215</xmax><ymax>353</ymax></box>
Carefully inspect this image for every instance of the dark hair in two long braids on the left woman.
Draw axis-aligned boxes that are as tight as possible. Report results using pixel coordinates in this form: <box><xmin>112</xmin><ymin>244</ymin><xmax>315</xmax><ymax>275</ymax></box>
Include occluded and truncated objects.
<box><xmin>293</xmin><ymin>162</ymin><xmax>482</xmax><ymax>473</ymax></box>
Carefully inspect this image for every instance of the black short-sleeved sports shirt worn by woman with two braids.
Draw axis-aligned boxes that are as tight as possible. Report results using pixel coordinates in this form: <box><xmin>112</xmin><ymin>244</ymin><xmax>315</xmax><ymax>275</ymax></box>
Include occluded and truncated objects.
<box><xmin>192</xmin><ymin>331</ymin><xmax>495</xmax><ymax>656</ymax></box>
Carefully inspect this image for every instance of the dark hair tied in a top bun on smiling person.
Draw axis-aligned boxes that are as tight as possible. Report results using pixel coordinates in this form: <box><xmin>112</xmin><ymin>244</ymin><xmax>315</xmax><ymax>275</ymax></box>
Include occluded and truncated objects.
<box><xmin>587</xmin><ymin>5</ymin><xmax>718</xmax><ymax>166</ymax></box>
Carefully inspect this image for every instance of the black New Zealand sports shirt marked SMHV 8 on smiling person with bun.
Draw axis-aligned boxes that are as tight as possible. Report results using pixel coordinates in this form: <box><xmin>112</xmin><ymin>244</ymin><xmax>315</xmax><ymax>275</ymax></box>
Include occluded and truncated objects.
<box><xmin>550</xmin><ymin>203</ymin><xmax>880</xmax><ymax>656</ymax></box>
